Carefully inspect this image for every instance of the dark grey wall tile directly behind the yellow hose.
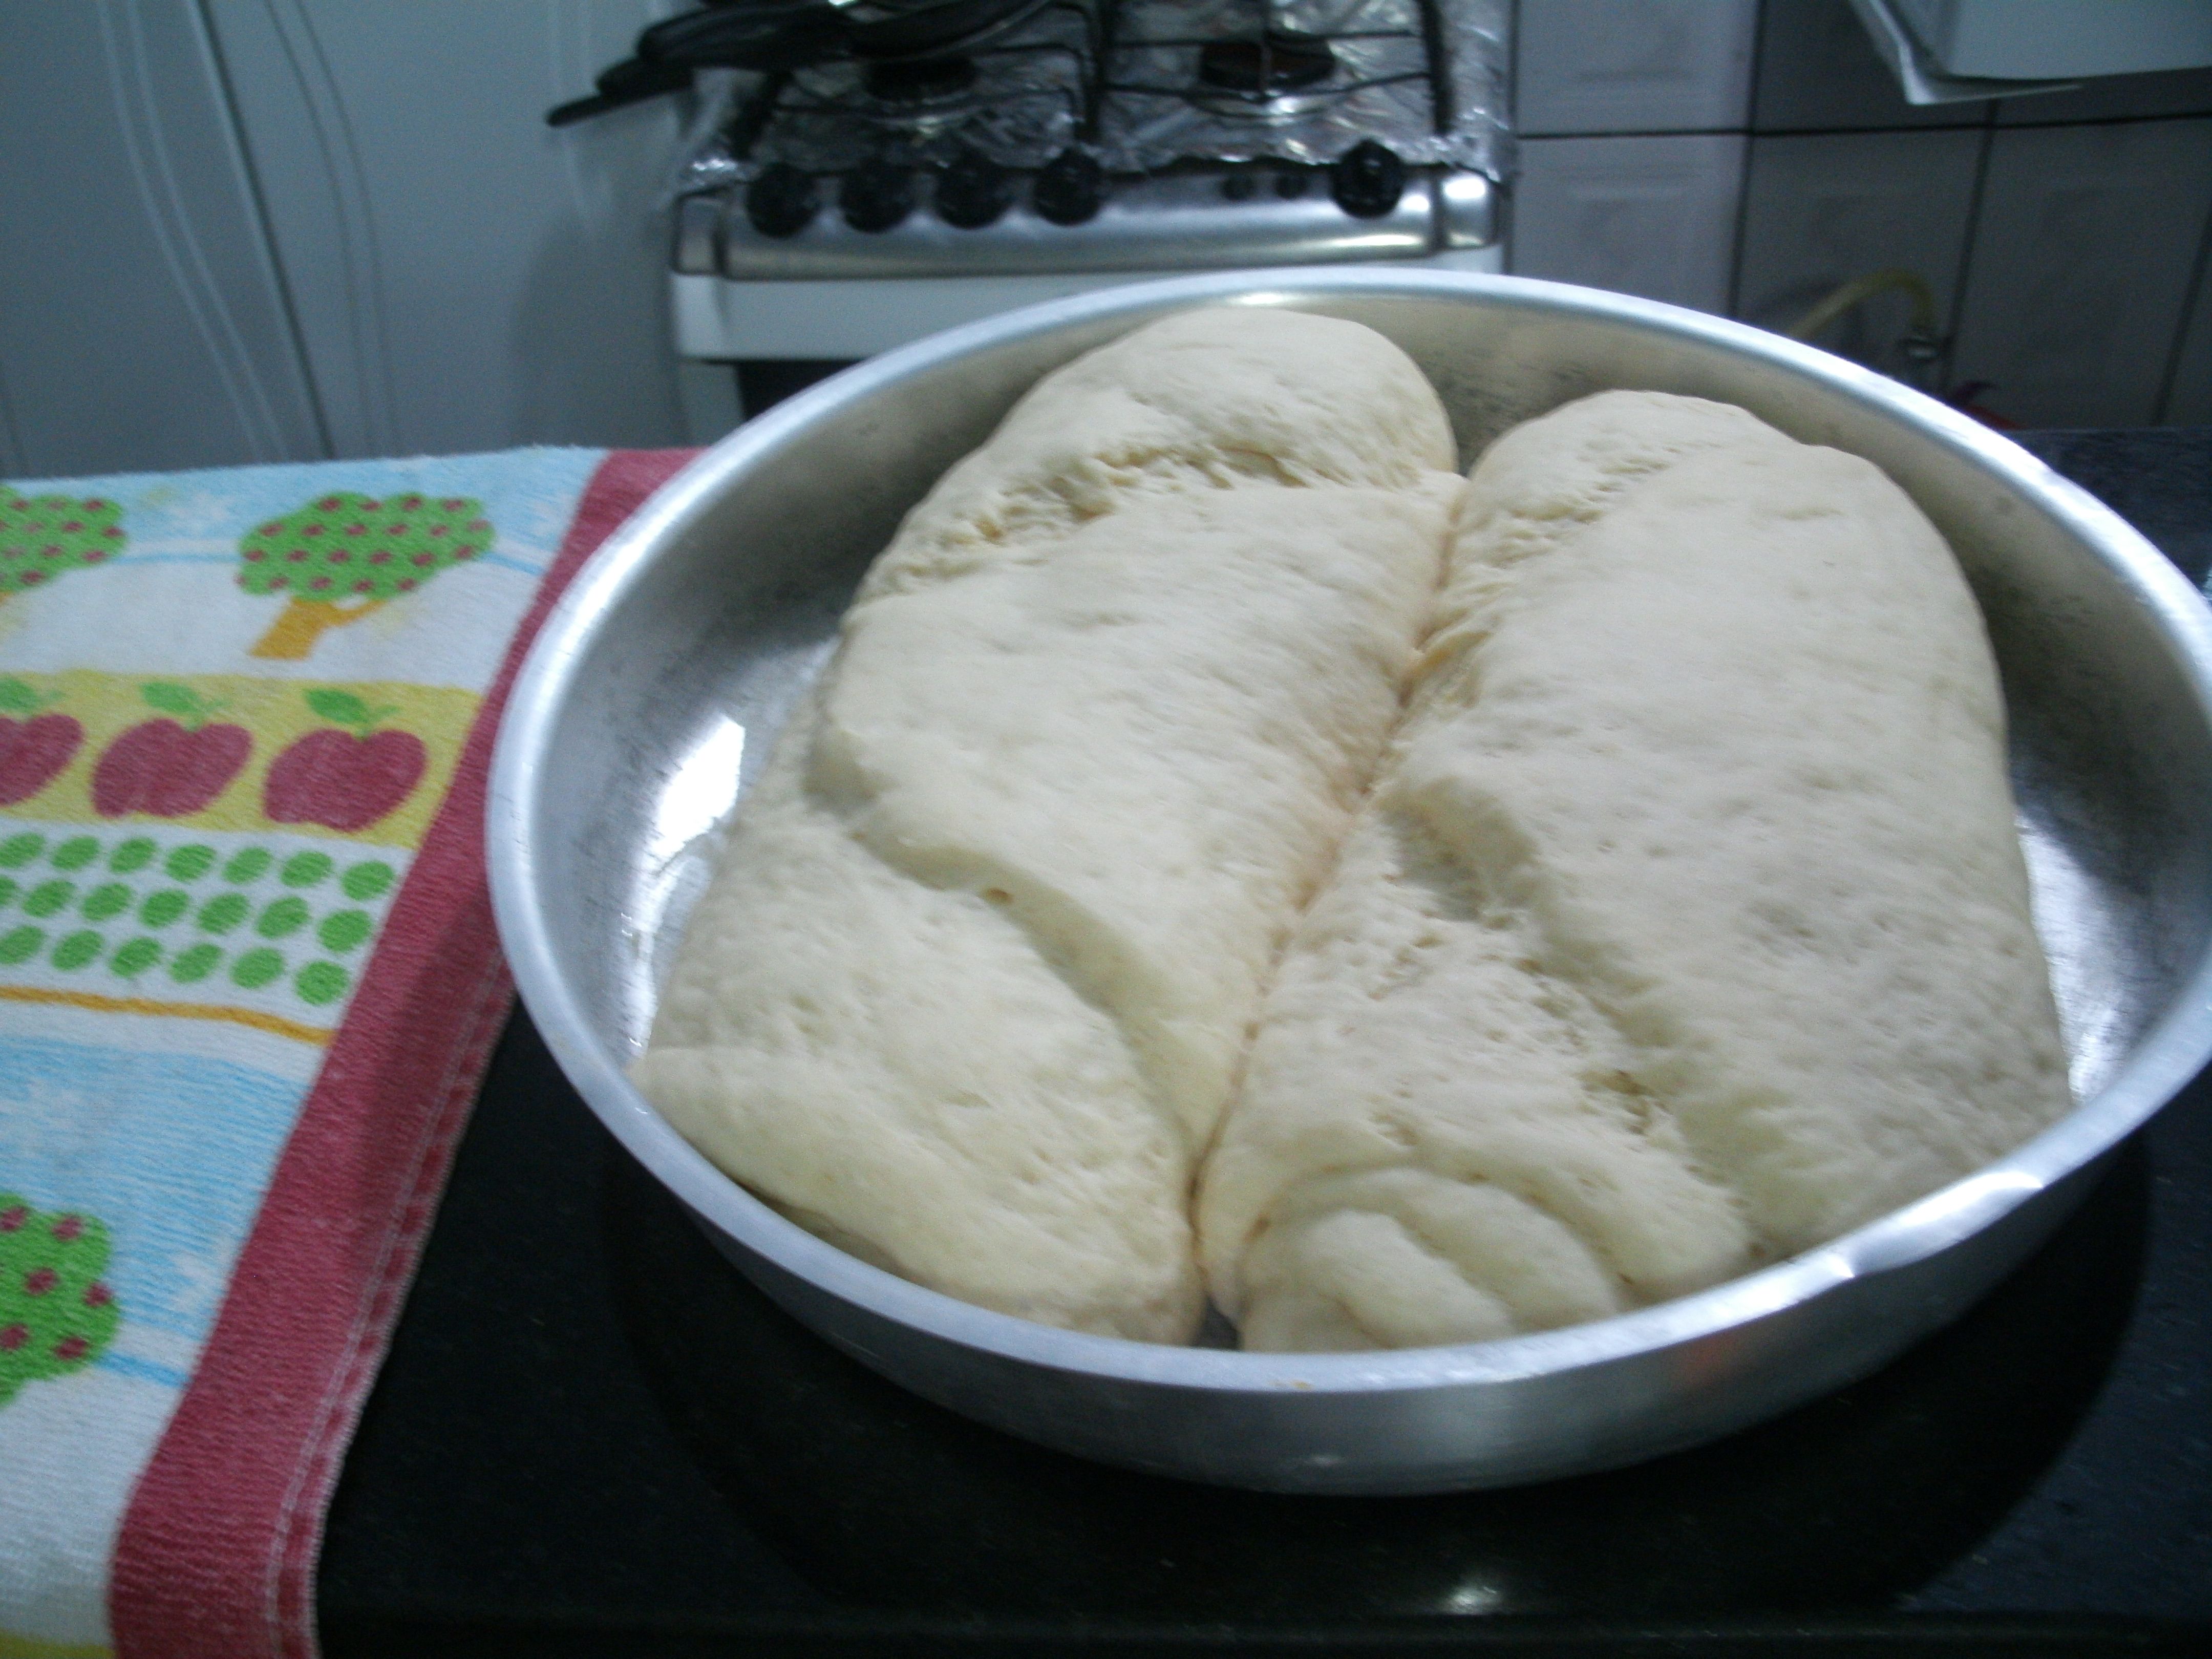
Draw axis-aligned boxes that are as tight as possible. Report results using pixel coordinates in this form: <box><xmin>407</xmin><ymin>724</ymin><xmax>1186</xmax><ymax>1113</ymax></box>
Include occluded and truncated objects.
<box><xmin>1736</xmin><ymin>129</ymin><xmax>1986</xmax><ymax>374</ymax></box>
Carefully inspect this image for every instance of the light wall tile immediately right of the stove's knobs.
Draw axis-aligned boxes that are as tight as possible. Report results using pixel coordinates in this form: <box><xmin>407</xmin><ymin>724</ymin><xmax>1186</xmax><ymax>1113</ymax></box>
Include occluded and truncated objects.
<box><xmin>1506</xmin><ymin>133</ymin><xmax>1743</xmax><ymax>312</ymax></box>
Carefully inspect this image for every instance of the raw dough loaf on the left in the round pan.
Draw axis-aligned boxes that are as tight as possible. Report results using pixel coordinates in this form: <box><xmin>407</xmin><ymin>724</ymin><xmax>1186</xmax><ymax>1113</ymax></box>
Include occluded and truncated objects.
<box><xmin>635</xmin><ymin>310</ymin><xmax>1464</xmax><ymax>1343</ymax></box>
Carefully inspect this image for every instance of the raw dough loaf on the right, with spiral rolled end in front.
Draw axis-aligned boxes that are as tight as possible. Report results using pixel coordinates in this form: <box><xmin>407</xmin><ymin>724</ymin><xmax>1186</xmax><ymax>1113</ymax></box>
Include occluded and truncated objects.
<box><xmin>1199</xmin><ymin>392</ymin><xmax>2068</xmax><ymax>1352</ymax></box>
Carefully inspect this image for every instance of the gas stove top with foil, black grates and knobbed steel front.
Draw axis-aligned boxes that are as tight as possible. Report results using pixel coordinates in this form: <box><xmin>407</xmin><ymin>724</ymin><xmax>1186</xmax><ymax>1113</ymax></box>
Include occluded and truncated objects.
<box><xmin>675</xmin><ymin>0</ymin><xmax>1511</xmax><ymax>285</ymax></box>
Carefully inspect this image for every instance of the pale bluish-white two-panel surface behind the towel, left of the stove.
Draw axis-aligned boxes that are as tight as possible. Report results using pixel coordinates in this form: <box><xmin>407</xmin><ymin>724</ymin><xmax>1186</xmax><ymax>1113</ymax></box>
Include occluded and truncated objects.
<box><xmin>0</xmin><ymin>0</ymin><xmax>686</xmax><ymax>476</ymax></box>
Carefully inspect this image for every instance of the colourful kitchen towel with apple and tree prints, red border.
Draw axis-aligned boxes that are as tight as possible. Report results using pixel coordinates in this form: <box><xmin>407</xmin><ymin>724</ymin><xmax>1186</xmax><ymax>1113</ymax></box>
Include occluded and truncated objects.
<box><xmin>0</xmin><ymin>449</ymin><xmax>690</xmax><ymax>1659</ymax></box>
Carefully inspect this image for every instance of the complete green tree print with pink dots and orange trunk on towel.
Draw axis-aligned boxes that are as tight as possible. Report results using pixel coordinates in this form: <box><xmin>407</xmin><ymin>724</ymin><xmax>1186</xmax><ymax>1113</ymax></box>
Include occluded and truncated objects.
<box><xmin>239</xmin><ymin>491</ymin><xmax>491</xmax><ymax>662</ymax></box>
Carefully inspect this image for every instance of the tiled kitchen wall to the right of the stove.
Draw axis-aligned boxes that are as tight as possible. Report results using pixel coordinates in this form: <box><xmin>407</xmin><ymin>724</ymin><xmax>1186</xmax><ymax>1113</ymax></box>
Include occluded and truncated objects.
<box><xmin>1508</xmin><ymin>0</ymin><xmax>2212</xmax><ymax>424</ymax></box>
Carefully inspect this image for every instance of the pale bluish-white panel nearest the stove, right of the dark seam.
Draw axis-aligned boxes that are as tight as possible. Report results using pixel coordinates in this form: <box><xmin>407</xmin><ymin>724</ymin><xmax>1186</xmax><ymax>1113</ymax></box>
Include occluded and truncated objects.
<box><xmin>208</xmin><ymin>0</ymin><xmax>684</xmax><ymax>456</ymax></box>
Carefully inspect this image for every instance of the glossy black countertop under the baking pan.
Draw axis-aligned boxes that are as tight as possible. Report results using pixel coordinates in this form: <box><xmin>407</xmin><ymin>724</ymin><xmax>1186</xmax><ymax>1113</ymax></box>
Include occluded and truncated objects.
<box><xmin>321</xmin><ymin>429</ymin><xmax>2212</xmax><ymax>1654</ymax></box>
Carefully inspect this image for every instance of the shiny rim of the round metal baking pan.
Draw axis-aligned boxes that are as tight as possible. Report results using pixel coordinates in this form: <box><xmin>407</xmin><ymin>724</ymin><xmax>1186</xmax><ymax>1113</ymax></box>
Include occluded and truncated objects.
<box><xmin>489</xmin><ymin>270</ymin><xmax>2212</xmax><ymax>1442</ymax></box>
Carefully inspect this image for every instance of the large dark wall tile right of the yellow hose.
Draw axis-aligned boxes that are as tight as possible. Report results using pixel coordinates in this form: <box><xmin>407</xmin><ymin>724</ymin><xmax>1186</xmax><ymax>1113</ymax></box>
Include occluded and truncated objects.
<box><xmin>1953</xmin><ymin>119</ymin><xmax>2212</xmax><ymax>427</ymax></box>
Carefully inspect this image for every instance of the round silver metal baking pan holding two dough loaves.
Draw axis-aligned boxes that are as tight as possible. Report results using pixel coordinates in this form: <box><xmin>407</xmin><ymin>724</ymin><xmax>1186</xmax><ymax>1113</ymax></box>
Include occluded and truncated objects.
<box><xmin>489</xmin><ymin>270</ymin><xmax>2212</xmax><ymax>1493</ymax></box>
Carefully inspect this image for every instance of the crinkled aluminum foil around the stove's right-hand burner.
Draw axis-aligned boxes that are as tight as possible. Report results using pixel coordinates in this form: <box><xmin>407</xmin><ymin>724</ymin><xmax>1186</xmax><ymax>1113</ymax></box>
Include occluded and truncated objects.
<box><xmin>1097</xmin><ymin>0</ymin><xmax>1511</xmax><ymax>179</ymax></box>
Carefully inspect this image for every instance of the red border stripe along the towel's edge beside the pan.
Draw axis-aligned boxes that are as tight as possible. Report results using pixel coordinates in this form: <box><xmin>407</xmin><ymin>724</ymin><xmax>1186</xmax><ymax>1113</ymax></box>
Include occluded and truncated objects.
<box><xmin>109</xmin><ymin>449</ymin><xmax>694</xmax><ymax>1659</ymax></box>
